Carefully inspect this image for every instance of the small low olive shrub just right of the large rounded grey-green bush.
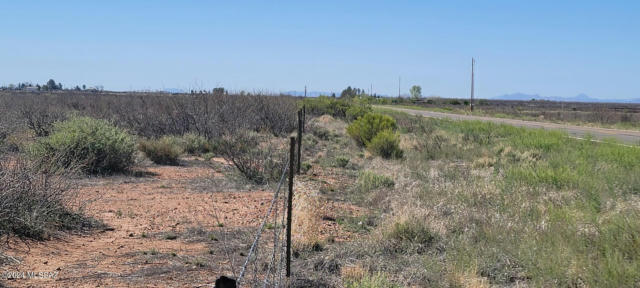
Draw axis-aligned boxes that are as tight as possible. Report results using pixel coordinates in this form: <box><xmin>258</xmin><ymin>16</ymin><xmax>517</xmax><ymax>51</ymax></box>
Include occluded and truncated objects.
<box><xmin>138</xmin><ymin>136</ymin><xmax>184</xmax><ymax>165</ymax></box>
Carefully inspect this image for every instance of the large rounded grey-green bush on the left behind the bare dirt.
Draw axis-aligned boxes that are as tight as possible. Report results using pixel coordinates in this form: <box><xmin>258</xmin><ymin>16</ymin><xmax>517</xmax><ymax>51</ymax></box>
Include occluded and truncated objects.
<box><xmin>30</xmin><ymin>117</ymin><xmax>135</xmax><ymax>174</ymax></box>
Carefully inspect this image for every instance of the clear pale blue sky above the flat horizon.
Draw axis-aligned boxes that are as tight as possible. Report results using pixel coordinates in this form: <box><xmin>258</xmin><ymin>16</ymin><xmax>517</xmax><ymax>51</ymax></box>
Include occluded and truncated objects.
<box><xmin>0</xmin><ymin>0</ymin><xmax>640</xmax><ymax>98</ymax></box>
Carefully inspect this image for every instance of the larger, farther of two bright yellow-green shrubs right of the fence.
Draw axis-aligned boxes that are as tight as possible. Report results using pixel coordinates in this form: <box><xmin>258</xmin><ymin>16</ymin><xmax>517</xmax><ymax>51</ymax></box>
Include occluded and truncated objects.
<box><xmin>347</xmin><ymin>113</ymin><xmax>396</xmax><ymax>146</ymax></box>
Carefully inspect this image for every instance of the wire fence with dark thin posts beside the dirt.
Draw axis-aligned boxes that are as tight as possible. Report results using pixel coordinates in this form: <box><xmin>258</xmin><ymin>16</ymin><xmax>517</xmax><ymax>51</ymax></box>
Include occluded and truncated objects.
<box><xmin>208</xmin><ymin>109</ymin><xmax>306</xmax><ymax>288</ymax></box>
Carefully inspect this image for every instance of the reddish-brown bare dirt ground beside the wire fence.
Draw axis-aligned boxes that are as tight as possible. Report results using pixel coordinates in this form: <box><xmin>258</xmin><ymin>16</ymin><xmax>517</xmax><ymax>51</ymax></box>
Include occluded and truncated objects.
<box><xmin>0</xmin><ymin>159</ymin><xmax>357</xmax><ymax>287</ymax></box>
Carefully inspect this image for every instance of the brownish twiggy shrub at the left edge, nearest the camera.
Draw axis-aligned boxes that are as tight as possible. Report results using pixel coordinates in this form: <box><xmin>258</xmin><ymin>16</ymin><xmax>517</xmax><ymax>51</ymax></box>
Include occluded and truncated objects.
<box><xmin>0</xmin><ymin>158</ymin><xmax>98</xmax><ymax>240</ymax></box>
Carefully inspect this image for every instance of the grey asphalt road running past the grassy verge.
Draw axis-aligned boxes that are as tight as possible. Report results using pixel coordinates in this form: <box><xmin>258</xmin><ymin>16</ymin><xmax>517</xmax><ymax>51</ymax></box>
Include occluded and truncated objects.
<box><xmin>384</xmin><ymin>106</ymin><xmax>640</xmax><ymax>145</ymax></box>
